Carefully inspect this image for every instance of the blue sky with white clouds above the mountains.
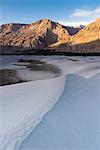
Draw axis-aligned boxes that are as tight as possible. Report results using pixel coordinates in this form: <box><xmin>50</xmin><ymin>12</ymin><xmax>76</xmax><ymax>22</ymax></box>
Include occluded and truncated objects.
<box><xmin>0</xmin><ymin>0</ymin><xmax>100</xmax><ymax>26</ymax></box>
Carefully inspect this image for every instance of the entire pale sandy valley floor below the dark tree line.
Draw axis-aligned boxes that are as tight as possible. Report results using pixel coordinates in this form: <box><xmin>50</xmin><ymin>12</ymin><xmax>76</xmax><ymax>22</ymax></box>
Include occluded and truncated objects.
<box><xmin>0</xmin><ymin>56</ymin><xmax>100</xmax><ymax>150</ymax></box>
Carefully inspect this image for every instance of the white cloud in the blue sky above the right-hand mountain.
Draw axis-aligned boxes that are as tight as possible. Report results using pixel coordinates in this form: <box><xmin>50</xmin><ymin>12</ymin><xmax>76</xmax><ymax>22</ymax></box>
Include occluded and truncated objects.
<box><xmin>58</xmin><ymin>6</ymin><xmax>100</xmax><ymax>26</ymax></box>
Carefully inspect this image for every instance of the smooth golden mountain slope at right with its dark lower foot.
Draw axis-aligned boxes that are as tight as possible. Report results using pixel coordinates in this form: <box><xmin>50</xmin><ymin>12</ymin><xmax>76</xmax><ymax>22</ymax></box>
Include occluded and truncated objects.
<box><xmin>49</xmin><ymin>18</ymin><xmax>100</xmax><ymax>53</ymax></box>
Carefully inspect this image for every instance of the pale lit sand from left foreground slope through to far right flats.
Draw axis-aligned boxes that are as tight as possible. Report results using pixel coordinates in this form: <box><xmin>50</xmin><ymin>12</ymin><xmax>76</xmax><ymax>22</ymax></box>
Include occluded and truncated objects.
<box><xmin>0</xmin><ymin>56</ymin><xmax>100</xmax><ymax>150</ymax></box>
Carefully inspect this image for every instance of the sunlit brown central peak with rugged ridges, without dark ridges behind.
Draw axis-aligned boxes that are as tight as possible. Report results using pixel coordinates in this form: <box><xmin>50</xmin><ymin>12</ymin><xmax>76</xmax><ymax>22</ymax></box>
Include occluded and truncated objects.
<box><xmin>0</xmin><ymin>19</ymin><xmax>70</xmax><ymax>48</ymax></box>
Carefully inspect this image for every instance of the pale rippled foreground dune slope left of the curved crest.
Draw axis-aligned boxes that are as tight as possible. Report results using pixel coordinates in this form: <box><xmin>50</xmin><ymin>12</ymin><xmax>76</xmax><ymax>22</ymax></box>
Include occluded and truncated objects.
<box><xmin>0</xmin><ymin>76</ymin><xmax>65</xmax><ymax>150</ymax></box>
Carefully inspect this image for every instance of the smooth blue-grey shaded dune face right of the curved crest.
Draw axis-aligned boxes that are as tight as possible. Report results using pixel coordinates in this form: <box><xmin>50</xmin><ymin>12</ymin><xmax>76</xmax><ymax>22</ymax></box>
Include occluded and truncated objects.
<box><xmin>20</xmin><ymin>73</ymin><xmax>100</xmax><ymax>150</ymax></box>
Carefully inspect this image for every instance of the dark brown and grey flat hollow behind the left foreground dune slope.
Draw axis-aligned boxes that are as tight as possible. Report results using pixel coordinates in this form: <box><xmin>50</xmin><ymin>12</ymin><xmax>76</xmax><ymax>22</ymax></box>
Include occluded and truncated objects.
<box><xmin>0</xmin><ymin>59</ymin><xmax>61</xmax><ymax>86</ymax></box>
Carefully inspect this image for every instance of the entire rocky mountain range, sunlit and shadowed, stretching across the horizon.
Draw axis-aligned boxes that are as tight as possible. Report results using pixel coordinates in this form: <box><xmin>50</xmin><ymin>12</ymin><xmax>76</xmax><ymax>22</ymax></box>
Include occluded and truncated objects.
<box><xmin>0</xmin><ymin>18</ymin><xmax>100</xmax><ymax>54</ymax></box>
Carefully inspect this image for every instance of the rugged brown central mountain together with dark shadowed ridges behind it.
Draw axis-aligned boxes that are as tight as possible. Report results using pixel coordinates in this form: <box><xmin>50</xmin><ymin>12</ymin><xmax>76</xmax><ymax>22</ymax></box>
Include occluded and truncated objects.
<box><xmin>0</xmin><ymin>19</ymin><xmax>81</xmax><ymax>48</ymax></box>
